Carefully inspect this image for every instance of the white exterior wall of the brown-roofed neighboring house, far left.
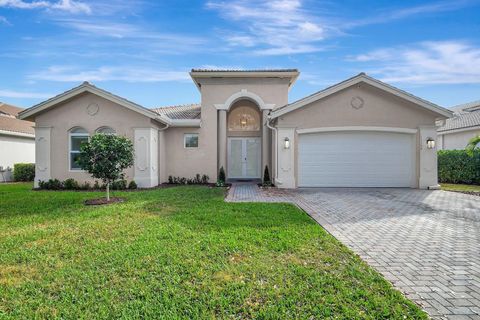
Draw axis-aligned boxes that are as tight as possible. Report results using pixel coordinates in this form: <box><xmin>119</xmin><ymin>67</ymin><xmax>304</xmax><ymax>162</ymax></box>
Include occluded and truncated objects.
<box><xmin>0</xmin><ymin>134</ymin><xmax>35</xmax><ymax>182</ymax></box>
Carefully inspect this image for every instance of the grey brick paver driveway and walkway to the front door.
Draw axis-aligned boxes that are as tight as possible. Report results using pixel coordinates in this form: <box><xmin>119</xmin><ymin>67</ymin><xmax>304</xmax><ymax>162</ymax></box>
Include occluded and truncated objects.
<box><xmin>227</xmin><ymin>185</ymin><xmax>480</xmax><ymax>319</ymax></box>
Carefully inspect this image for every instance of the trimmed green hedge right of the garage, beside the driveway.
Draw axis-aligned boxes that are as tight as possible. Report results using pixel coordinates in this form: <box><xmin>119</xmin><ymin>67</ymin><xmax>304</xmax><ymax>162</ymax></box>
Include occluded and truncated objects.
<box><xmin>438</xmin><ymin>150</ymin><xmax>480</xmax><ymax>184</ymax></box>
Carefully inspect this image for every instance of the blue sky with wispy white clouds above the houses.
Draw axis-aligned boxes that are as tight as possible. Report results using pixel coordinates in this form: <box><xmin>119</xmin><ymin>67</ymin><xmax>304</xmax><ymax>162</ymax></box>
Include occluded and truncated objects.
<box><xmin>0</xmin><ymin>0</ymin><xmax>480</xmax><ymax>107</ymax></box>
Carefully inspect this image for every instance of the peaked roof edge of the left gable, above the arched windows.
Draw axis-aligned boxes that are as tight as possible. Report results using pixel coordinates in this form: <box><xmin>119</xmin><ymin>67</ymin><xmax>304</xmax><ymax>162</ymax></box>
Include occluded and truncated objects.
<box><xmin>18</xmin><ymin>82</ymin><xmax>170</xmax><ymax>124</ymax></box>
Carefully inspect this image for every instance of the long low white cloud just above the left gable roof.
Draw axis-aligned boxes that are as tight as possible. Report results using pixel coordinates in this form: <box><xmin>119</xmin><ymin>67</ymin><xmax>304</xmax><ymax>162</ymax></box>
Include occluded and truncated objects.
<box><xmin>28</xmin><ymin>66</ymin><xmax>190</xmax><ymax>82</ymax></box>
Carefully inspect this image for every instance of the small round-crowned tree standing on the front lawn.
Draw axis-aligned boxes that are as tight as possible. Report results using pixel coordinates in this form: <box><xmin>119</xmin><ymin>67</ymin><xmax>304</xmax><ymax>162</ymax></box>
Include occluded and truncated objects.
<box><xmin>77</xmin><ymin>133</ymin><xmax>133</xmax><ymax>201</ymax></box>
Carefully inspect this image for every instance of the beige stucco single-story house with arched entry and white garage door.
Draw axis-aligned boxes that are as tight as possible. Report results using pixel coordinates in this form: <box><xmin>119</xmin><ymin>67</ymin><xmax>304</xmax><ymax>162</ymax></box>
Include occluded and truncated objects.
<box><xmin>20</xmin><ymin>69</ymin><xmax>452</xmax><ymax>188</ymax></box>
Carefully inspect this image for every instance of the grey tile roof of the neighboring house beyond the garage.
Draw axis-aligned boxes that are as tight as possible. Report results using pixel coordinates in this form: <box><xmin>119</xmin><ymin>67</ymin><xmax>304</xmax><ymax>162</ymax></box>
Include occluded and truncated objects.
<box><xmin>438</xmin><ymin>100</ymin><xmax>480</xmax><ymax>132</ymax></box>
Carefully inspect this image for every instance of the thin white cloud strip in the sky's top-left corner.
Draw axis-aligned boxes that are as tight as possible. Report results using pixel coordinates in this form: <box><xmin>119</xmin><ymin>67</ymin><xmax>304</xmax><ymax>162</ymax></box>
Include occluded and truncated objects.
<box><xmin>0</xmin><ymin>0</ymin><xmax>91</xmax><ymax>14</ymax></box>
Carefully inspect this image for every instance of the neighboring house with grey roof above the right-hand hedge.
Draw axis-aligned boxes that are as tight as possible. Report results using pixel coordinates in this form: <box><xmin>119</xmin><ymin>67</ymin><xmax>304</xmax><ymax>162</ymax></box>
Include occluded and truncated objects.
<box><xmin>438</xmin><ymin>100</ymin><xmax>480</xmax><ymax>150</ymax></box>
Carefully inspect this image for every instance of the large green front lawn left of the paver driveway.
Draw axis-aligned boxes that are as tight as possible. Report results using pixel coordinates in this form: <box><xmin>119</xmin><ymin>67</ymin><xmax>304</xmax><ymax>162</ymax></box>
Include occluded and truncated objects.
<box><xmin>0</xmin><ymin>184</ymin><xmax>427</xmax><ymax>319</ymax></box>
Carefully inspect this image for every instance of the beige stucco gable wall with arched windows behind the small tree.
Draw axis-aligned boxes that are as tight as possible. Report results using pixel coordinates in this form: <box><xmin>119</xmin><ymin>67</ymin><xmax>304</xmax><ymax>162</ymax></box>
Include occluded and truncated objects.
<box><xmin>35</xmin><ymin>93</ymin><xmax>163</xmax><ymax>182</ymax></box>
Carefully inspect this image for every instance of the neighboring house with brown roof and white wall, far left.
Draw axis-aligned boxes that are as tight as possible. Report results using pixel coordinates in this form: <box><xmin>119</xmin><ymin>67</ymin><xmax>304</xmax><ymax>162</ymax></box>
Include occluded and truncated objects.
<box><xmin>0</xmin><ymin>102</ymin><xmax>35</xmax><ymax>182</ymax></box>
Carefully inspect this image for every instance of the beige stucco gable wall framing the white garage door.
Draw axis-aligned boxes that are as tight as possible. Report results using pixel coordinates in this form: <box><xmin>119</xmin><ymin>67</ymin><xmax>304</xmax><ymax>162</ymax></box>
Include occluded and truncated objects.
<box><xmin>277</xmin><ymin>84</ymin><xmax>439</xmax><ymax>186</ymax></box>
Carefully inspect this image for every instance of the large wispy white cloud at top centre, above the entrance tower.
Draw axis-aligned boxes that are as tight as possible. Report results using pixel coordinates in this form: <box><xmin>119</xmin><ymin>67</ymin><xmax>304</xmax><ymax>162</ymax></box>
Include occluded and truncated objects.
<box><xmin>207</xmin><ymin>0</ymin><xmax>332</xmax><ymax>55</ymax></box>
